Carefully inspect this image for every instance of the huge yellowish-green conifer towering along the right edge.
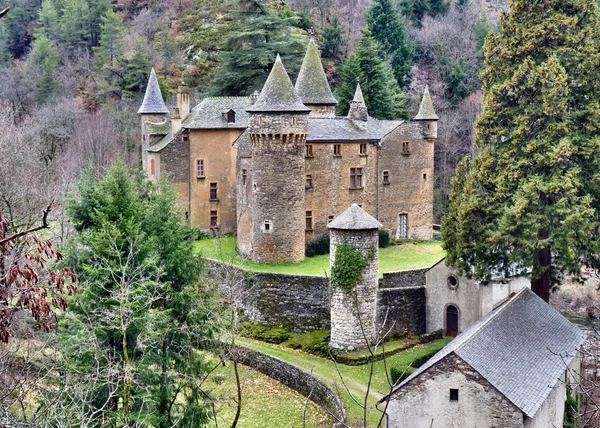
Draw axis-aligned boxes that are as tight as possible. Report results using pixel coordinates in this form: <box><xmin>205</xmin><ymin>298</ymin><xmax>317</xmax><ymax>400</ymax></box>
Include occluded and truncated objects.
<box><xmin>442</xmin><ymin>0</ymin><xmax>600</xmax><ymax>301</ymax></box>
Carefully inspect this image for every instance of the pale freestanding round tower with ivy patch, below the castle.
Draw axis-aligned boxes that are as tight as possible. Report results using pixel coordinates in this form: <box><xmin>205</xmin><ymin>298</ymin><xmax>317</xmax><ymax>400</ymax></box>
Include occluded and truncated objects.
<box><xmin>327</xmin><ymin>204</ymin><xmax>382</xmax><ymax>350</ymax></box>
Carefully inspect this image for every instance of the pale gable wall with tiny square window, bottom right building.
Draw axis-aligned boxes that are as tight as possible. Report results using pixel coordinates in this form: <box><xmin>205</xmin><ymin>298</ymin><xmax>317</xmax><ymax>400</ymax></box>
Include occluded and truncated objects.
<box><xmin>386</xmin><ymin>354</ymin><xmax>523</xmax><ymax>428</ymax></box>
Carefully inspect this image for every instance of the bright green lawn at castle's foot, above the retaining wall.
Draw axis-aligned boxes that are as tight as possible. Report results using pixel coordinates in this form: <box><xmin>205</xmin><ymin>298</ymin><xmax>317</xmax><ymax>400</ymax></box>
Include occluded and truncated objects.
<box><xmin>195</xmin><ymin>236</ymin><xmax>446</xmax><ymax>276</ymax></box>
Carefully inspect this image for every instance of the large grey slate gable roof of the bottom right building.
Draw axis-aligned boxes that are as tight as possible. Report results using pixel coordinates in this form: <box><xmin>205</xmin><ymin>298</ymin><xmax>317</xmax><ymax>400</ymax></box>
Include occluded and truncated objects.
<box><xmin>381</xmin><ymin>288</ymin><xmax>586</xmax><ymax>418</ymax></box>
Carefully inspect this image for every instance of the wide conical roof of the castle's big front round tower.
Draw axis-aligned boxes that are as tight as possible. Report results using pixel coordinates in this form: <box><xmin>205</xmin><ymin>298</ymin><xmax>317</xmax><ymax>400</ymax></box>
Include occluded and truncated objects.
<box><xmin>246</xmin><ymin>55</ymin><xmax>310</xmax><ymax>112</ymax></box>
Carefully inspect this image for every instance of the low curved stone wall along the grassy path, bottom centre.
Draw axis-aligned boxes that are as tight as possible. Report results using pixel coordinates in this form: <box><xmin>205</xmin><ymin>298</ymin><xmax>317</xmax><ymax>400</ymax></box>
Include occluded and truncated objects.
<box><xmin>235</xmin><ymin>348</ymin><xmax>345</xmax><ymax>426</ymax></box>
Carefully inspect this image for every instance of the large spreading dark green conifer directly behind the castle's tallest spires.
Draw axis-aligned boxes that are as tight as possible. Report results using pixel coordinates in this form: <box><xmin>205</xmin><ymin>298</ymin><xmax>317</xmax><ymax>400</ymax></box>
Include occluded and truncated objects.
<box><xmin>209</xmin><ymin>0</ymin><xmax>306</xmax><ymax>95</ymax></box>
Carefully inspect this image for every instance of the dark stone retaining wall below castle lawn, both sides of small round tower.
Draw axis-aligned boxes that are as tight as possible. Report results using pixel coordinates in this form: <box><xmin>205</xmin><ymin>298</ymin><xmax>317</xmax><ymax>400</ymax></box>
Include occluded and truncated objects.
<box><xmin>209</xmin><ymin>261</ymin><xmax>425</xmax><ymax>335</ymax></box>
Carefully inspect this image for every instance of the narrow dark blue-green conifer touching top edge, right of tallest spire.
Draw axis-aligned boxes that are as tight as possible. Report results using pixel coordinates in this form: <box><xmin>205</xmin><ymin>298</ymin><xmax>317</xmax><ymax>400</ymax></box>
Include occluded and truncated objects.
<box><xmin>366</xmin><ymin>0</ymin><xmax>413</xmax><ymax>87</ymax></box>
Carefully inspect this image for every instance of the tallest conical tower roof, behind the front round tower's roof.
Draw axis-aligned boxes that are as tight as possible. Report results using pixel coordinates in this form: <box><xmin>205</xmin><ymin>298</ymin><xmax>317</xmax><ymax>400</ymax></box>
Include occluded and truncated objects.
<box><xmin>296</xmin><ymin>39</ymin><xmax>337</xmax><ymax>105</ymax></box>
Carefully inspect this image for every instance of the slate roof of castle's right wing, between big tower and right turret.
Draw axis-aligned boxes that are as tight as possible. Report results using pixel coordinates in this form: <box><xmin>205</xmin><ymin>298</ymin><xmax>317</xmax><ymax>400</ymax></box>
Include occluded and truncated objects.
<box><xmin>307</xmin><ymin>117</ymin><xmax>402</xmax><ymax>142</ymax></box>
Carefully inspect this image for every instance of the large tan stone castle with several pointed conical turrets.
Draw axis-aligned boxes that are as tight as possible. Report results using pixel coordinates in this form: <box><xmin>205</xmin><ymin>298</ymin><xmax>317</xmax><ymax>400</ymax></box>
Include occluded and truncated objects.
<box><xmin>139</xmin><ymin>41</ymin><xmax>438</xmax><ymax>263</ymax></box>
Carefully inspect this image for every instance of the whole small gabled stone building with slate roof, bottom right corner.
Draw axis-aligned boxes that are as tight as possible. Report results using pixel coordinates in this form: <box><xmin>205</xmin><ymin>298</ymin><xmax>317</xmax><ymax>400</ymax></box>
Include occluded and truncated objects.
<box><xmin>378</xmin><ymin>289</ymin><xmax>586</xmax><ymax>428</ymax></box>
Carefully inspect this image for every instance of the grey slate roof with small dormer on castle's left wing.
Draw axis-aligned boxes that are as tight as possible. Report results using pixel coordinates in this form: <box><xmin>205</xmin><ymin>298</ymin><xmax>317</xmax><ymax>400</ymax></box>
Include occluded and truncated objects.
<box><xmin>181</xmin><ymin>97</ymin><xmax>251</xmax><ymax>129</ymax></box>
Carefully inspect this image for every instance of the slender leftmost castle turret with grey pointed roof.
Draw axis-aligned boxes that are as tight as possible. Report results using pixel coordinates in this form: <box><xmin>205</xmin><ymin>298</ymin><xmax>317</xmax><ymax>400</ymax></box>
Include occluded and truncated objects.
<box><xmin>138</xmin><ymin>68</ymin><xmax>169</xmax><ymax>173</ymax></box>
